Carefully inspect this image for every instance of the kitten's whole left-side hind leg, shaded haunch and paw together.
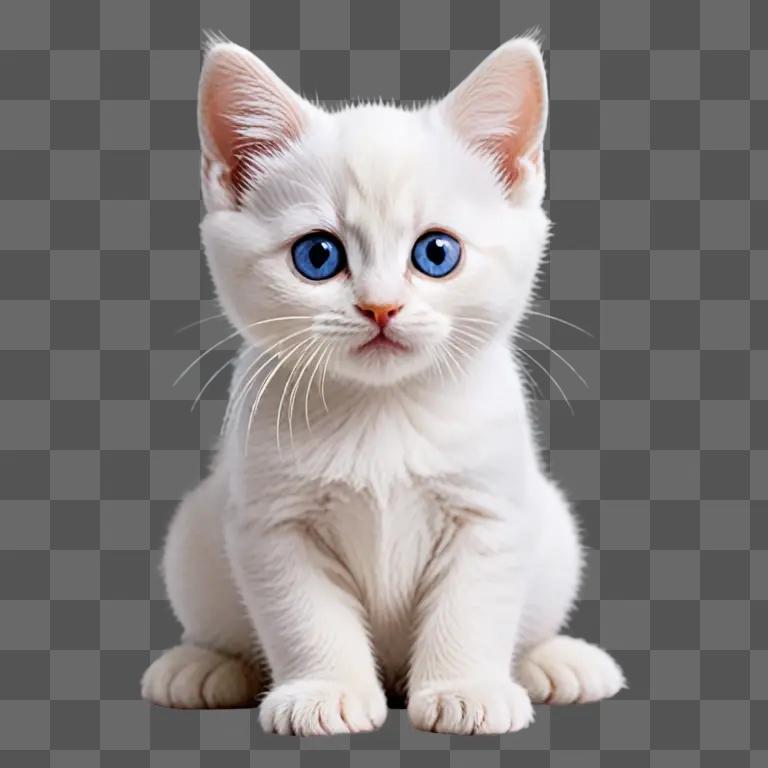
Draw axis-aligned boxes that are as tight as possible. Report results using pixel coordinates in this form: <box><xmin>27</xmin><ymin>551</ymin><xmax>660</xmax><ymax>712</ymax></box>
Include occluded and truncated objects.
<box><xmin>141</xmin><ymin>474</ymin><xmax>262</xmax><ymax>709</ymax></box>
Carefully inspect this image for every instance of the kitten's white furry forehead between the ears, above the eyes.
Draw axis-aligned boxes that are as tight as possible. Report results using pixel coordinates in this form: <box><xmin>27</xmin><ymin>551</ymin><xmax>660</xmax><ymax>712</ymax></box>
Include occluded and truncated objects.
<box><xmin>249</xmin><ymin>100</ymin><xmax>506</xmax><ymax>258</ymax></box>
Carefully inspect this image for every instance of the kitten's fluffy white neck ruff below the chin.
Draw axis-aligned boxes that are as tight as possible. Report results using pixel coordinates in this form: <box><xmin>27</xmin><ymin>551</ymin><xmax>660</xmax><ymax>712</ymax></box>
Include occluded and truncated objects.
<box><xmin>227</xmin><ymin>342</ymin><xmax>527</xmax><ymax>495</ymax></box>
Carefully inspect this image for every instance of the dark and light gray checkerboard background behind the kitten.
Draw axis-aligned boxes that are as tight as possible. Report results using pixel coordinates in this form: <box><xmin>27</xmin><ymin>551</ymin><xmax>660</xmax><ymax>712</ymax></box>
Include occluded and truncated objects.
<box><xmin>0</xmin><ymin>0</ymin><xmax>768</xmax><ymax>768</ymax></box>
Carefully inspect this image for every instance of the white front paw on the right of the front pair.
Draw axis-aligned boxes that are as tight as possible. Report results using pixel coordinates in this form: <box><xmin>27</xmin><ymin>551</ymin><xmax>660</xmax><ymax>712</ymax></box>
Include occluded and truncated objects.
<box><xmin>408</xmin><ymin>680</ymin><xmax>533</xmax><ymax>734</ymax></box>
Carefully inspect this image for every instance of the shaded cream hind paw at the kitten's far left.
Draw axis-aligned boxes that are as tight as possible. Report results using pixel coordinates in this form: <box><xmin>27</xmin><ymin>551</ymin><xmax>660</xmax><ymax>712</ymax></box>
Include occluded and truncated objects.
<box><xmin>141</xmin><ymin>645</ymin><xmax>258</xmax><ymax>709</ymax></box>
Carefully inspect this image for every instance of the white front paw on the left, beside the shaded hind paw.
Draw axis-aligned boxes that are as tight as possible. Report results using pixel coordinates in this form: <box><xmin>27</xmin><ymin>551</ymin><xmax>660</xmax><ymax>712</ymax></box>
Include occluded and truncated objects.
<box><xmin>259</xmin><ymin>680</ymin><xmax>387</xmax><ymax>736</ymax></box>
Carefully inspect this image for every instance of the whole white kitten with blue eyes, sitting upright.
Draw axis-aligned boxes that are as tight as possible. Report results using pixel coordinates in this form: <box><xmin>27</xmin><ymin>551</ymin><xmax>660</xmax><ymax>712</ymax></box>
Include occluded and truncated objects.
<box><xmin>143</xmin><ymin>39</ymin><xmax>624</xmax><ymax>735</ymax></box>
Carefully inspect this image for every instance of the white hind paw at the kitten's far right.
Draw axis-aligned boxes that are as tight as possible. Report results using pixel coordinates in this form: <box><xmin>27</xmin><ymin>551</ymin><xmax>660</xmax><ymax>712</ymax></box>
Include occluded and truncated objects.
<box><xmin>517</xmin><ymin>635</ymin><xmax>626</xmax><ymax>704</ymax></box>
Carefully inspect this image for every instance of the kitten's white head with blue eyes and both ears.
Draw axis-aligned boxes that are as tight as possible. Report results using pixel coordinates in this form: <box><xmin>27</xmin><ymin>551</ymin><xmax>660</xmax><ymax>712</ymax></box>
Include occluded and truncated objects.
<box><xmin>199</xmin><ymin>38</ymin><xmax>548</xmax><ymax>386</ymax></box>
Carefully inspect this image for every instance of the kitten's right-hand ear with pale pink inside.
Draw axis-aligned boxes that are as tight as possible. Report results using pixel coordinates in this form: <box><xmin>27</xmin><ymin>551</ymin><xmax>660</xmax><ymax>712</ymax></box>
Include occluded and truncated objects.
<box><xmin>439</xmin><ymin>38</ymin><xmax>547</xmax><ymax>202</ymax></box>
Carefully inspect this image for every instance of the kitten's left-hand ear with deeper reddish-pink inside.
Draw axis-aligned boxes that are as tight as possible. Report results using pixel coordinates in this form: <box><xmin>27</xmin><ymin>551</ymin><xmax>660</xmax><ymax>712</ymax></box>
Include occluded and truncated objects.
<box><xmin>197</xmin><ymin>42</ymin><xmax>315</xmax><ymax>210</ymax></box>
